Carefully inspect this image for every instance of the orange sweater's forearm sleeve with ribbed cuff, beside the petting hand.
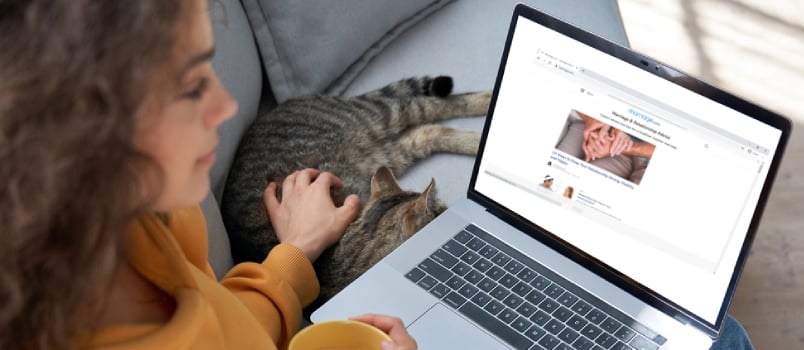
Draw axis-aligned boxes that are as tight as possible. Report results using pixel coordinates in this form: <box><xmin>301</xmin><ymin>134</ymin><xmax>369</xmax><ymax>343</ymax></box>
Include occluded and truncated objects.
<box><xmin>221</xmin><ymin>244</ymin><xmax>319</xmax><ymax>348</ymax></box>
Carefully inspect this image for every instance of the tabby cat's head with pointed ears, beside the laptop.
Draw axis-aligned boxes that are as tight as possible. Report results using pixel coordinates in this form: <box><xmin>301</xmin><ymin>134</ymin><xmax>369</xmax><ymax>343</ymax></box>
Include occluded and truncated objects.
<box><xmin>359</xmin><ymin>167</ymin><xmax>447</xmax><ymax>237</ymax></box>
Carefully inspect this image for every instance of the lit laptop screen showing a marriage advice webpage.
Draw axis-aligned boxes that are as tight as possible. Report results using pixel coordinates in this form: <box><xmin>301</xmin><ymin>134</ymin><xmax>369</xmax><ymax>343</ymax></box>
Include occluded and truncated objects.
<box><xmin>472</xmin><ymin>11</ymin><xmax>782</xmax><ymax>327</ymax></box>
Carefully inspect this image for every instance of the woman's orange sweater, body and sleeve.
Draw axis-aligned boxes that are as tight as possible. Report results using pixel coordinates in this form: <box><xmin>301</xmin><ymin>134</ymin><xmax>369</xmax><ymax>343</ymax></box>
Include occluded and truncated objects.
<box><xmin>85</xmin><ymin>207</ymin><xmax>319</xmax><ymax>350</ymax></box>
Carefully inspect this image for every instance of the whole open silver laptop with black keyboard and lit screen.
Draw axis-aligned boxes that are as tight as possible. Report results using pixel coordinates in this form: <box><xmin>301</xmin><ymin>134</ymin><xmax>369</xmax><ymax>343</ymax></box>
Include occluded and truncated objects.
<box><xmin>312</xmin><ymin>5</ymin><xmax>791</xmax><ymax>350</ymax></box>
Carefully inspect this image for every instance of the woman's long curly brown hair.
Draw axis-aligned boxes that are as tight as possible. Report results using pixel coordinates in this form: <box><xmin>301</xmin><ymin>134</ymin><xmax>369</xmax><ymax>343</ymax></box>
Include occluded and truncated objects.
<box><xmin>0</xmin><ymin>0</ymin><xmax>190</xmax><ymax>349</ymax></box>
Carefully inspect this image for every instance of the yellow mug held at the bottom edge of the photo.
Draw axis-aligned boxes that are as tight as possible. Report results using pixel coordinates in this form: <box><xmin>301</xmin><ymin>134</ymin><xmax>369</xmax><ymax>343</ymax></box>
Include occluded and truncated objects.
<box><xmin>288</xmin><ymin>320</ymin><xmax>391</xmax><ymax>350</ymax></box>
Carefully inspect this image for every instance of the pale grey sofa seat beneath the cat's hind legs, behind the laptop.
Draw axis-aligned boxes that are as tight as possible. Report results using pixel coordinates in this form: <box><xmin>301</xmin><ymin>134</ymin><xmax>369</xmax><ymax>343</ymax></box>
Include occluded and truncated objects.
<box><xmin>345</xmin><ymin>0</ymin><xmax>628</xmax><ymax>205</ymax></box>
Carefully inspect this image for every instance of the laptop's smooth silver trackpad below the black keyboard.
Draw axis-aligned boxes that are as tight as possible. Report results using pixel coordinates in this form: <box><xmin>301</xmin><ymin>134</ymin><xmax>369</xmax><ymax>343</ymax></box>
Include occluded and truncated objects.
<box><xmin>408</xmin><ymin>304</ymin><xmax>509</xmax><ymax>350</ymax></box>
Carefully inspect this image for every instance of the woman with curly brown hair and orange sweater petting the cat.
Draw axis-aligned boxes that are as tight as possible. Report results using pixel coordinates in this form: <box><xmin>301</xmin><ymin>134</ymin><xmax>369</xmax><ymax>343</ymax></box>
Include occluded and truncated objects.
<box><xmin>0</xmin><ymin>0</ymin><xmax>743</xmax><ymax>349</ymax></box>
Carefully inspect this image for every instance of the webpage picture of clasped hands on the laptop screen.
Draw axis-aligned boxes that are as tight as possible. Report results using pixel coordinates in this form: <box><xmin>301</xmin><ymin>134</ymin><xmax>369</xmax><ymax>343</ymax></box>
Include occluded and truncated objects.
<box><xmin>556</xmin><ymin>109</ymin><xmax>656</xmax><ymax>185</ymax></box>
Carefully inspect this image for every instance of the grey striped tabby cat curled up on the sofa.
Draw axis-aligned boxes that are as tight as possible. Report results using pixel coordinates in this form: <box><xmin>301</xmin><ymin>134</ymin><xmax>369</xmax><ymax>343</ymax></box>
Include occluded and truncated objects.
<box><xmin>221</xmin><ymin>77</ymin><xmax>491</xmax><ymax>301</ymax></box>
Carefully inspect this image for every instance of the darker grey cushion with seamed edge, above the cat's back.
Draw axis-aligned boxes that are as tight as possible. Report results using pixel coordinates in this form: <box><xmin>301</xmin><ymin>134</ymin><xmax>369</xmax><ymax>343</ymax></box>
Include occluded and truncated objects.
<box><xmin>242</xmin><ymin>0</ymin><xmax>451</xmax><ymax>102</ymax></box>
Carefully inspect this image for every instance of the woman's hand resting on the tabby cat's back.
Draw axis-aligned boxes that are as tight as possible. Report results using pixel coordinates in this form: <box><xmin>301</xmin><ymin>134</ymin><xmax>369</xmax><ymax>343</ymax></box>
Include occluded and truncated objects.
<box><xmin>263</xmin><ymin>169</ymin><xmax>360</xmax><ymax>262</ymax></box>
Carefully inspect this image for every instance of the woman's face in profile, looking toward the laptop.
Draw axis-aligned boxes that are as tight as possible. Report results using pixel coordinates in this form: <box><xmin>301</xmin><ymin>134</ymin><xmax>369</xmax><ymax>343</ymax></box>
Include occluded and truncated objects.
<box><xmin>136</xmin><ymin>0</ymin><xmax>237</xmax><ymax>211</ymax></box>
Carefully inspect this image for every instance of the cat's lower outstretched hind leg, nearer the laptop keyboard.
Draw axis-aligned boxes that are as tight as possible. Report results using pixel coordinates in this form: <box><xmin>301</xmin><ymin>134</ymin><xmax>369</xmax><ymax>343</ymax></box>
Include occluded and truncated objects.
<box><xmin>386</xmin><ymin>124</ymin><xmax>480</xmax><ymax>175</ymax></box>
